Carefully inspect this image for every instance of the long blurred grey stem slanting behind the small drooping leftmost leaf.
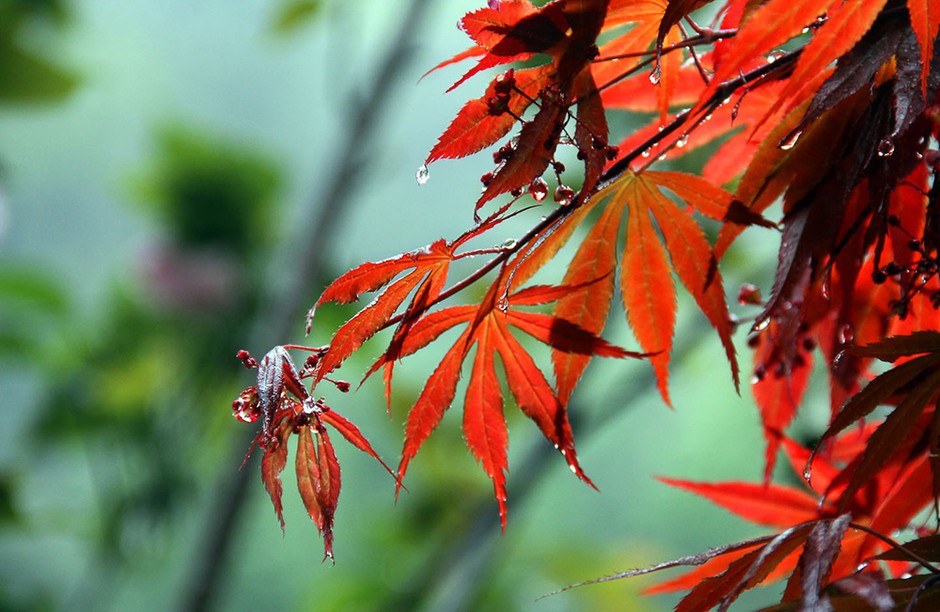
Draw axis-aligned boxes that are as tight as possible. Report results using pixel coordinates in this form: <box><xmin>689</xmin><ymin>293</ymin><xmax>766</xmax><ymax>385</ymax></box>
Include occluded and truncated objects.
<box><xmin>182</xmin><ymin>0</ymin><xmax>428</xmax><ymax>611</ymax></box>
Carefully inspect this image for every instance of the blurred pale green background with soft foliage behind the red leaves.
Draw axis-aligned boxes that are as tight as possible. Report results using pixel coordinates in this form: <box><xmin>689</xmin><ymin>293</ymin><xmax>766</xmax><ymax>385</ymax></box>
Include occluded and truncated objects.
<box><xmin>0</xmin><ymin>0</ymin><xmax>814</xmax><ymax>610</ymax></box>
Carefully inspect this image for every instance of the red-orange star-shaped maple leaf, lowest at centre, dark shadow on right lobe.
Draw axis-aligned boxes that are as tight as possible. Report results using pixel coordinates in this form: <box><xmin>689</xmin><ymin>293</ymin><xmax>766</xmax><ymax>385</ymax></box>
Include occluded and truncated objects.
<box><xmin>370</xmin><ymin>277</ymin><xmax>643</xmax><ymax>528</ymax></box>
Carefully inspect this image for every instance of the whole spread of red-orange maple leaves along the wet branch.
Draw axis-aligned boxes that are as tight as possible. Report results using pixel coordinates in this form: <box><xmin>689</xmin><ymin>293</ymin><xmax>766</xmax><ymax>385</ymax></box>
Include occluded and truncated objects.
<box><xmin>231</xmin><ymin>0</ymin><xmax>940</xmax><ymax>610</ymax></box>
